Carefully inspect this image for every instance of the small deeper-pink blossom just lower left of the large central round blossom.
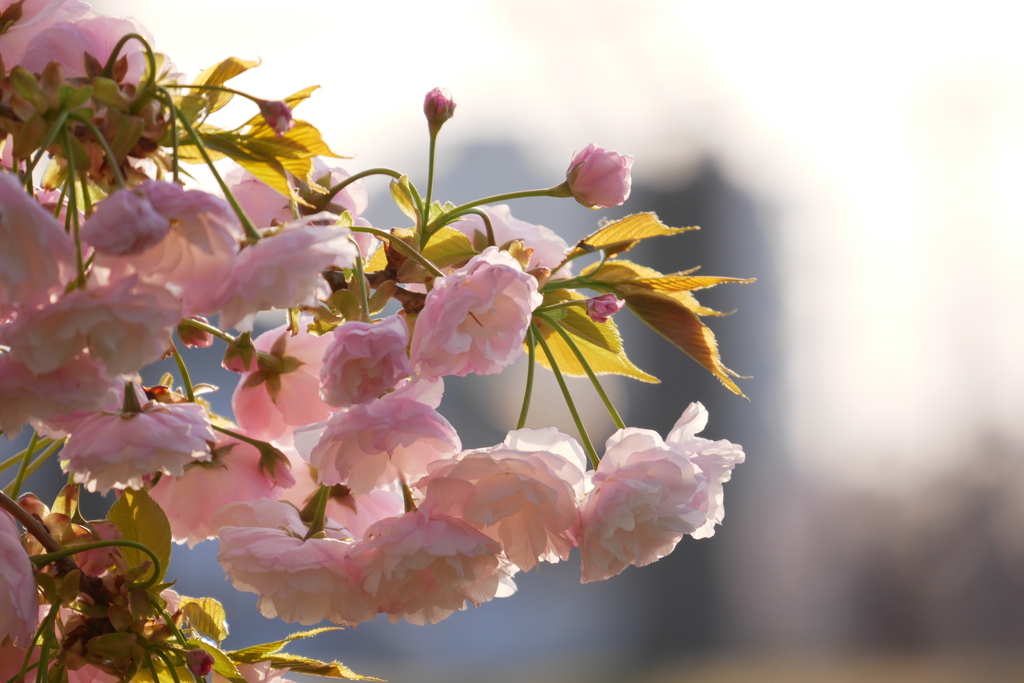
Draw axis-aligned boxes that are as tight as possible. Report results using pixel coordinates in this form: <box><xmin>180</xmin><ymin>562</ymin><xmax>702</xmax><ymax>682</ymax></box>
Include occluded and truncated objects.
<box><xmin>321</xmin><ymin>315</ymin><xmax>412</xmax><ymax>408</ymax></box>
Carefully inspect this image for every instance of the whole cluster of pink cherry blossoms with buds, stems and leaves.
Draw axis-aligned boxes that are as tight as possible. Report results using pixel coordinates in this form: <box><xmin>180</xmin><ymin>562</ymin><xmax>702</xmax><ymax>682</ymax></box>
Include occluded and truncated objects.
<box><xmin>0</xmin><ymin>0</ymin><xmax>748</xmax><ymax>681</ymax></box>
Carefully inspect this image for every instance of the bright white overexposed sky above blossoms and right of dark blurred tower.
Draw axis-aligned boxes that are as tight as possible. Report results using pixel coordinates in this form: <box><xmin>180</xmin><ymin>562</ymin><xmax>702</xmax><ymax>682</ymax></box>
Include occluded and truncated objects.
<box><xmin>95</xmin><ymin>0</ymin><xmax>1024</xmax><ymax>491</ymax></box>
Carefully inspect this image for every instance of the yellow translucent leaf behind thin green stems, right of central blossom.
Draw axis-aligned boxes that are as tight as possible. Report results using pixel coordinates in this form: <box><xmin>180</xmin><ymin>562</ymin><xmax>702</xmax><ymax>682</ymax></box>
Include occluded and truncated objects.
<box><xmin>534</xmin><ymin>292</ymin><xmax>658</xmax><ymax>382</ymax></box>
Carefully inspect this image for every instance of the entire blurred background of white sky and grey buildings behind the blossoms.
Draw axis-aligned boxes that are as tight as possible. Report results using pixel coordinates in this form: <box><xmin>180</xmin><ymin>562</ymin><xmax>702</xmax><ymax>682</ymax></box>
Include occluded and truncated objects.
<box><xmin>8</xmin><ymin>0</ymin><xmax>1024</xmax><ymax>683</ymax></box>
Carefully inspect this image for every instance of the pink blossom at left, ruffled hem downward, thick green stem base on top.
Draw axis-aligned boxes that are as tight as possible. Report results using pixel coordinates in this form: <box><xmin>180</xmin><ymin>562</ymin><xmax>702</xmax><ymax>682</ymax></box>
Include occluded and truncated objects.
<box><xmin>60</xmin><ymin>401</ymin><xmax>215</xmax><ymax>494</ymax></box>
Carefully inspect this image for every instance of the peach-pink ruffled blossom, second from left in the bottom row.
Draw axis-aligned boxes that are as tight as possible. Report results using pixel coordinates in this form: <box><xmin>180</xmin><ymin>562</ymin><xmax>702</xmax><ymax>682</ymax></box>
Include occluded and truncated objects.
<box><xmin>348</xmin><ymin>511</ymin><xmax>501</xmax><ymax>625</ymax></box>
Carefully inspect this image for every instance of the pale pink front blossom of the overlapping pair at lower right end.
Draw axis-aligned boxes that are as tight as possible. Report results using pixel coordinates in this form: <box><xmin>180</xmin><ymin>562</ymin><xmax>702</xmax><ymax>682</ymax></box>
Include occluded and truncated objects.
<box><xmin>579</xmin><ymin>427</ymin><xmax>707</xmax><ymax>583</ymax></box>
